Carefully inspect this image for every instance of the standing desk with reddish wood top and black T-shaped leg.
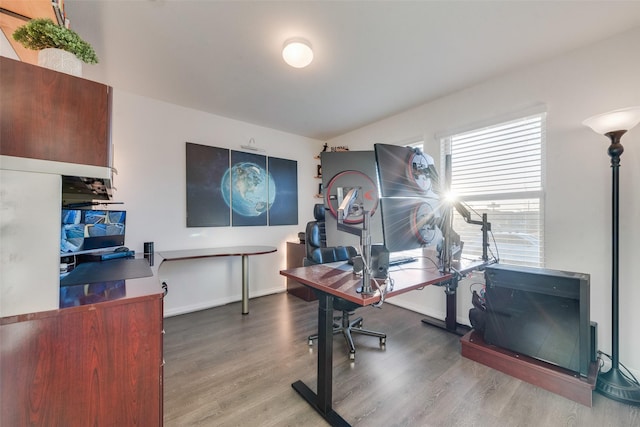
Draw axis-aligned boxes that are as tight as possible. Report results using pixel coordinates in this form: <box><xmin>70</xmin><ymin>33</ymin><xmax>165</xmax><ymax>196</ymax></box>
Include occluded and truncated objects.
<box><xmin>280</xmin><ymin>260</ymin><xmax>452</xmax><ymax>426</ymax></box>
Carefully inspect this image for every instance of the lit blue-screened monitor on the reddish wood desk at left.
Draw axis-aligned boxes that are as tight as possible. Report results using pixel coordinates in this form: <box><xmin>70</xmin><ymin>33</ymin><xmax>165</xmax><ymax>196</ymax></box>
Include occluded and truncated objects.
<box><xmin>60</xmin><ymin>209</ymin><xmax>127</xmax><ymax>256</ymax></box>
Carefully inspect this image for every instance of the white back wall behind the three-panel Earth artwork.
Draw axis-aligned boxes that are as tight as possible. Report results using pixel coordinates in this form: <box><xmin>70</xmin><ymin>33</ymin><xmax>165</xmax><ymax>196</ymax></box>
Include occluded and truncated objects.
<box><xmin>112</xmin><ymin>88</ymin><xmax>322</xmax><ymax>315</ymax></box>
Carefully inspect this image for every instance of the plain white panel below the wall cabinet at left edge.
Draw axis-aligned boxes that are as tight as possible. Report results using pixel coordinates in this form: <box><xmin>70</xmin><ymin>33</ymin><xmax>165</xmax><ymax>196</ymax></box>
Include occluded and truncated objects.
<box><xmin>0</xmin><ymin>169</ymin><xmax>62</xmax><ymax>317</ymax></box>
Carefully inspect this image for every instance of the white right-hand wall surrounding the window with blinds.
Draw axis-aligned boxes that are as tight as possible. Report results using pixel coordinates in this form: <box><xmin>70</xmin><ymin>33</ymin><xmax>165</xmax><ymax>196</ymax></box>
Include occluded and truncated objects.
<box><xmin>329</xmin><ymin>29</ymin><xmax>640</xmax><ymax>370</ymax></box>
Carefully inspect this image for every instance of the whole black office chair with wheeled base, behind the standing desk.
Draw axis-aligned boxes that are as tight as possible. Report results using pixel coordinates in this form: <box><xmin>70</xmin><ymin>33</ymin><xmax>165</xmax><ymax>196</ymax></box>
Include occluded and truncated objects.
<box><xmin>303</xmin><ymin>204</ymin><xmax>387</xmax><ymax>360</ymax></box>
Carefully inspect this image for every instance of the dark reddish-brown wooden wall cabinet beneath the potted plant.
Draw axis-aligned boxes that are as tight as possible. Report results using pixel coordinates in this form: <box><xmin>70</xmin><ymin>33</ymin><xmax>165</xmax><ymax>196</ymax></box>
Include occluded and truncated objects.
<box><xmin>0</xmin><ymin>57</ymin><xmax>112</xmax><ymax>167</ymax></box>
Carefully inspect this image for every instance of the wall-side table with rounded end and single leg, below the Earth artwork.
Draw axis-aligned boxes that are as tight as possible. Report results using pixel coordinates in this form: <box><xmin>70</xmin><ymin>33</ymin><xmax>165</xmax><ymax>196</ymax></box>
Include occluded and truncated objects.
<box><xmin>158</xmin><ymin>246</ymin><xmax>278</xmax><ymax>314</ymax></box>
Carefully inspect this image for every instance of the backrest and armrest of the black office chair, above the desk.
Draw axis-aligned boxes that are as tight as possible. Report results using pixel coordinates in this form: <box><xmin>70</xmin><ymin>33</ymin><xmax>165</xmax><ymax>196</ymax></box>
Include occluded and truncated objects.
<box><xmin>304</xmin><ymin>203</ymin><xmax>357</xmax><ymax>265</ymax></box>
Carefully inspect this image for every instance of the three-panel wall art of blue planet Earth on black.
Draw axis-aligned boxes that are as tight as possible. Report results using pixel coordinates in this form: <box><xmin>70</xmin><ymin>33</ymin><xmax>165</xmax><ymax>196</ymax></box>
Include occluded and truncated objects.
<box><xmin>186</xmin><ymin>142</ymin><xmax>298</xmax><ymax>227</ymax></box>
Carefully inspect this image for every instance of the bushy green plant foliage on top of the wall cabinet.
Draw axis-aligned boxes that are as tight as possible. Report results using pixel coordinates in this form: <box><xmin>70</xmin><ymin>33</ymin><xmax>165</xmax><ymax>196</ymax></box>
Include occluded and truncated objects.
<box><xmin>13</xmin><ymin>18</ymin><xmax>98</xmax><ymax>64</ymax></box>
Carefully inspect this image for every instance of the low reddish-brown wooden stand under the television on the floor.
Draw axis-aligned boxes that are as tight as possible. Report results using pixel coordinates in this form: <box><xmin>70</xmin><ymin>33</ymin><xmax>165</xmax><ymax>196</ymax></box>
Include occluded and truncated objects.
<box><xmin>460</xmin><ymin>330</ymin><xmax>598</xmax><ymax>407</ymax></box>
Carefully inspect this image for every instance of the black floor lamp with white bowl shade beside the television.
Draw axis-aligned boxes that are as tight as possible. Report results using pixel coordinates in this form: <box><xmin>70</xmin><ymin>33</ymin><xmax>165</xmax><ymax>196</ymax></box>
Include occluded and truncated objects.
<box><xmin>583</xmin><ymin>107</ymin><xmax>640</xmax><ymax>406</ymax></box>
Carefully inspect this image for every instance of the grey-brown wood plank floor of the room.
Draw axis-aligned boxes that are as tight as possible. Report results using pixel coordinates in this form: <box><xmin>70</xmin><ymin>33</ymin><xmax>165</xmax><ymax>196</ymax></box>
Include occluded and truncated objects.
<box><xmin>164</xmin><ymin>293</ymin><xmax>640</xmax><ymax>427</ymax></box>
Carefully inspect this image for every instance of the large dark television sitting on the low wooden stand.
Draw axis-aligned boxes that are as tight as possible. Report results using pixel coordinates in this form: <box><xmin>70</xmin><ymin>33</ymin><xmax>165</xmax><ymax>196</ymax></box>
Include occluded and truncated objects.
<box><xmin>484</xmin><ymin>264</ymin><xmax>595</xmax><ymax>377</ymax></box>
